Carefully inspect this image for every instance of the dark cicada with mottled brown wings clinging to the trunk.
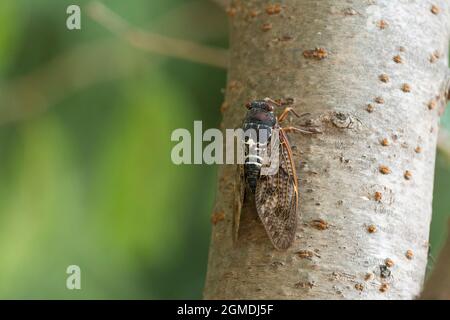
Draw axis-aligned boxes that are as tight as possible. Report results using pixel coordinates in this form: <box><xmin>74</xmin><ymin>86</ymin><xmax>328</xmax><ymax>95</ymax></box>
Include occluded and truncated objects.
<box><xmin>233</xmin><ymin>98</ymin><xmax>312</xmax><ymax>250</ymax></box>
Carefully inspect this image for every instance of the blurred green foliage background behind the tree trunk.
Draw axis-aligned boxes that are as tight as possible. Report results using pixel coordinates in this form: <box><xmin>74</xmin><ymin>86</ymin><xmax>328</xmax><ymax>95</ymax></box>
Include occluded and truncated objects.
<box><xmin>0</xmin><ymin>0</ymin><xmax>450</xmax><ymax>299</ymax></box>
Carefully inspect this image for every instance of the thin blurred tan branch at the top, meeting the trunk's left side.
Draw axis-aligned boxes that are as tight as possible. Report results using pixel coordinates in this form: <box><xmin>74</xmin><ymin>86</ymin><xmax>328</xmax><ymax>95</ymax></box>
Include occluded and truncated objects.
<box><xmin>87</xmin><ymin>1</ymin><xmax>228</xmax><ymax>68</ymax></box>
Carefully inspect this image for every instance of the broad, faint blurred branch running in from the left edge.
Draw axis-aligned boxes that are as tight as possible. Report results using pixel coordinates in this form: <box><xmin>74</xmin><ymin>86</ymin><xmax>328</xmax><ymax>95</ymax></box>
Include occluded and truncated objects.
<box><xmin>0</xmin><ymin>41</ymin><xmax>148</xmax><ymax>125</ymax></box>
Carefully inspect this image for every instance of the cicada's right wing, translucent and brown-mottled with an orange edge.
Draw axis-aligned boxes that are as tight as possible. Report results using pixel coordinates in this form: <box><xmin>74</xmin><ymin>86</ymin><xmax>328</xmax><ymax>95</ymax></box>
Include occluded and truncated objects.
<box><xmin>255</xmin><ymin>130</ymin><xmax>298</xmax><ymax>250</ymax></box>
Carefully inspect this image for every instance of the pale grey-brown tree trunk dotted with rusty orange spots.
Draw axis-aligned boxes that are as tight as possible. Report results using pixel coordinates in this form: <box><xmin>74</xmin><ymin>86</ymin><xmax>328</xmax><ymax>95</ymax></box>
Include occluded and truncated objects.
<box><xmin>204</xmin><ymin>0</ymin><xmax>450</xmax><ymax>299</ymax></box>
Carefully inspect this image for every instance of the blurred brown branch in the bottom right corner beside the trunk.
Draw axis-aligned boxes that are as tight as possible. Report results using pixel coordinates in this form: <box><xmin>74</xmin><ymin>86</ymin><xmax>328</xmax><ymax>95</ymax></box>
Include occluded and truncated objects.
<box><xmin>421</xmin><ymin>220</ymin><xmax>450</xmax><ymax>300</ymax></box>
